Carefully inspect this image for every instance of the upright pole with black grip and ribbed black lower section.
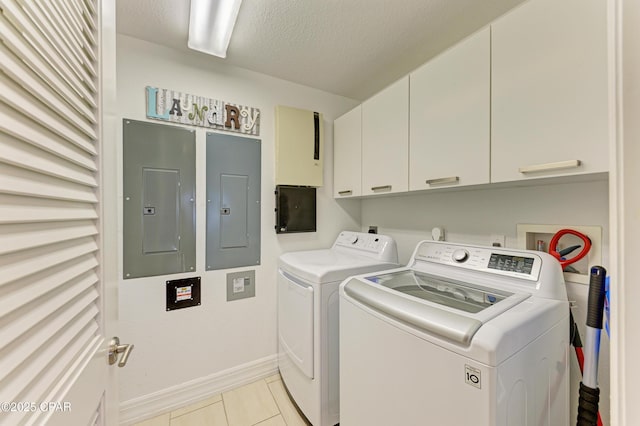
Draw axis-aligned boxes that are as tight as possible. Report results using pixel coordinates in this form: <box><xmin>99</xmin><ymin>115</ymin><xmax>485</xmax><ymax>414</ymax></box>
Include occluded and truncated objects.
<box><xmin>577</xmin><ymin>266</ymin><xmax>607</xmax><ymax>426</ymax></box>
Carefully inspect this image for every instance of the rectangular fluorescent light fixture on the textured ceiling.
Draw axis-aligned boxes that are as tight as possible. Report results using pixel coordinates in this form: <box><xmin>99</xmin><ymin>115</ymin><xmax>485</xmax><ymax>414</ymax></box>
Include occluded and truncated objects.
<box><xmin>187</xmin><ymin>0</ymin><xmax>242</xmax><ymax>58</ymax></box>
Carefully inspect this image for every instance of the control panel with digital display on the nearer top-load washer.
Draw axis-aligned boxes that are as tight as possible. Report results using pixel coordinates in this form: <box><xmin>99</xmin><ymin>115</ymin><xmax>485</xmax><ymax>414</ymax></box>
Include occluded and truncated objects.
<box><xmin>414</xmin><ymin>241</ymin><xmax>542</xmax><ymax>281</ymax></box>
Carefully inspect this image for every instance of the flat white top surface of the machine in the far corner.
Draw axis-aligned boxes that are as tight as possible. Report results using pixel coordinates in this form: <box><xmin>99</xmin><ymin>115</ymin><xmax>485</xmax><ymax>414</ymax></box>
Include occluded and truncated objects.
<box><xmin>278</xmin><ymin>249</ymin><xmax>398</xmax><ymax>284</ymax></box>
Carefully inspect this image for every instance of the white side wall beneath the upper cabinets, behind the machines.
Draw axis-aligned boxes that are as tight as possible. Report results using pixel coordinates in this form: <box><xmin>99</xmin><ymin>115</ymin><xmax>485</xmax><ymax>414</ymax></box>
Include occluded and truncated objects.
<box><xmin>362</xmin><ymin>180</ymin><xmax>609</xmax><ymax>424</ymax></box>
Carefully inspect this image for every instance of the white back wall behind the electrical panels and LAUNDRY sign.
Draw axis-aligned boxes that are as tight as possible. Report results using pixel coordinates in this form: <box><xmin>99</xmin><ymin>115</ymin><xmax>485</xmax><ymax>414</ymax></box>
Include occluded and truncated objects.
<box><xmin>114</xmin><ymin>36</ymin><xmax>360</xmax><ymax>417</ymax></box>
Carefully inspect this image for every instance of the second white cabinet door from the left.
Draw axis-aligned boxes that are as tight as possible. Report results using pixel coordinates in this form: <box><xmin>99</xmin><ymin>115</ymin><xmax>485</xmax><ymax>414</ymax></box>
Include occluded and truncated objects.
<box><xmin>362</xmin><ymin>76</ymin><xmax>409</xmax><ymax>195</ymax></box>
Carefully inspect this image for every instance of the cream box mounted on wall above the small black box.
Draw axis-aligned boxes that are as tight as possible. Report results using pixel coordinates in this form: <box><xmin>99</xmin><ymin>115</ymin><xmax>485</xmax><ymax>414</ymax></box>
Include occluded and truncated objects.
<box><xmin>276</xmin><ymin>105</ymin><xmax>324</xmax><ymax>186</ymax></box>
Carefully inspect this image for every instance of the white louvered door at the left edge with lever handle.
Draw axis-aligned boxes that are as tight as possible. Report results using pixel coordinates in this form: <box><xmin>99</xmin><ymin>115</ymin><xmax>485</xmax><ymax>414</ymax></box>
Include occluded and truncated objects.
<box><xmin>0</xmin><ymin>0</ymin><xmax>116</xmax><ymax>425</ymax></box>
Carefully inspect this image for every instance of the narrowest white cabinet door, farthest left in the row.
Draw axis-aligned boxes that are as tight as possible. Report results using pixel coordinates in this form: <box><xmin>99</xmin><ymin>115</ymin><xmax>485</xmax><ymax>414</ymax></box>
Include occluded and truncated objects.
<box><xmin>333</xmin><ymin>105</ymin><xmax>362</xmax><ymax>198</ymax></box>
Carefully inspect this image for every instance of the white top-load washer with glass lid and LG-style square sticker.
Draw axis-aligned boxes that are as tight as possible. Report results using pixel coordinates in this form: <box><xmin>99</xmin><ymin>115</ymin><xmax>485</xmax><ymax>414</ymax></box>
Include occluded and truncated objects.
<box><xmin>340</xmin><ymin>241</ymin><xmax>569</xmax><ymax>426</ymax></box>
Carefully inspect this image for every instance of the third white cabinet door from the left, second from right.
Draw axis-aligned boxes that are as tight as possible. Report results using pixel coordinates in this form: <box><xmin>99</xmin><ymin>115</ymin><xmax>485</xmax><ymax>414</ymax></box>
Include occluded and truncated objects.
<box><xmin>409</xmin><ymin>27</ymin><xmax>491</xmax><ymax>190</ymax></box>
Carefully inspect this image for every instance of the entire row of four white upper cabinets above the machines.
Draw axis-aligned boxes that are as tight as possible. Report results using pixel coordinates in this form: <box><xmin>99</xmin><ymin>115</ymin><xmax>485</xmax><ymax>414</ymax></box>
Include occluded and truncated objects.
<box><xmin>334</xmin><ymin>0</ymin><xmax>614</xmax><ymax>198</ymax></box>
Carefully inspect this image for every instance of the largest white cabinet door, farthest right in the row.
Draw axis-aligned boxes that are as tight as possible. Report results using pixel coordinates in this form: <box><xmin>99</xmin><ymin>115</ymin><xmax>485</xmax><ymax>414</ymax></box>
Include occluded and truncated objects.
<box><xmin>491</xmin><ymin>0</ymin><xmax>610</xmax><ymax>182</ymax></box>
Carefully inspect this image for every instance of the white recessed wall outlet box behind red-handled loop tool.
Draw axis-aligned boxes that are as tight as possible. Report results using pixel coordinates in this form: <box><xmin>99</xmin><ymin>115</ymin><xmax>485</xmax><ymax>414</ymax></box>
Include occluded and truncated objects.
<box><xmin>516</xmin><ymin>223</ymin><xmax>604</xmax><ymax>285</ymax></box>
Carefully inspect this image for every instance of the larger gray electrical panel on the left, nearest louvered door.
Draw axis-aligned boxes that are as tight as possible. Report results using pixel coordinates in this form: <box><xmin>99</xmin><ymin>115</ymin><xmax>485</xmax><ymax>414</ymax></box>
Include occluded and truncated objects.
<box><xmin>122</xmin><ymin>119</ymin><xmax>196</xmax><ymax>279</ymax></box>
